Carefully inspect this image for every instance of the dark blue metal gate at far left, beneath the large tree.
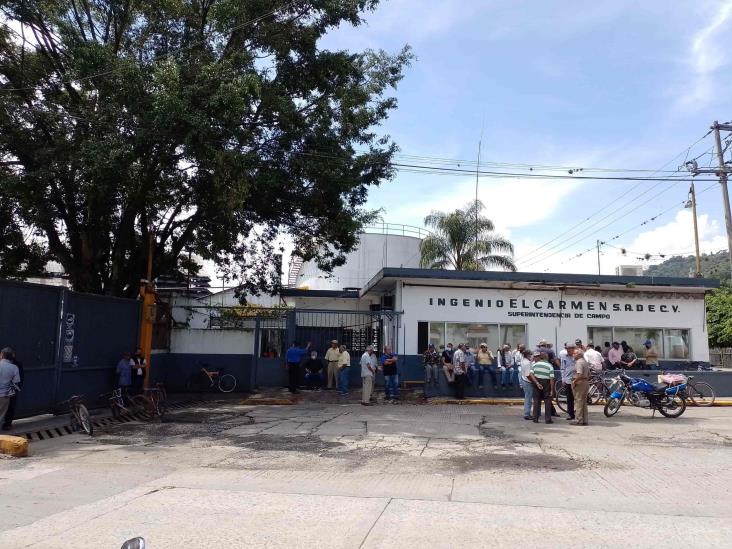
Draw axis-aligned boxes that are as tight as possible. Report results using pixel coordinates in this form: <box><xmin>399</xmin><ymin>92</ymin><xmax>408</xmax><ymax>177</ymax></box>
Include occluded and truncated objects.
<box><xmin>0</xmin><ymin>280</ymin><xmax>140</xmax><ymax>417</ymax></box>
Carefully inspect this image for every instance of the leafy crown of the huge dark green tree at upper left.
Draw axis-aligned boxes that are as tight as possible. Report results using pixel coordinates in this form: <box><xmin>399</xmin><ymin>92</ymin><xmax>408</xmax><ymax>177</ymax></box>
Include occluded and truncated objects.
<box><xmin>0</xmin><ymin>0</ymin><xmax>411</xmax><ymax>295</ymax></box>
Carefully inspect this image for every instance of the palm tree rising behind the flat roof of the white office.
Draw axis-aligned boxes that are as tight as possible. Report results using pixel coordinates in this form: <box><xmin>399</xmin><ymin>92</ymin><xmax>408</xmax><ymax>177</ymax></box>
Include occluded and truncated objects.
<box><xmin>420</xmin><ymin>200</ymin><xmax>516</xmax><ymax>271</ymax></box>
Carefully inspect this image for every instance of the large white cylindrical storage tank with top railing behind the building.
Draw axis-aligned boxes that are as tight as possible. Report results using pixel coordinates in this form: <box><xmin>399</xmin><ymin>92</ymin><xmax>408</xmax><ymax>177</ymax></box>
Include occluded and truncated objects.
<box><xmin>291</xmin><ymin>224</ymin><xmax>429</xmax><ymax>290</ymax></box>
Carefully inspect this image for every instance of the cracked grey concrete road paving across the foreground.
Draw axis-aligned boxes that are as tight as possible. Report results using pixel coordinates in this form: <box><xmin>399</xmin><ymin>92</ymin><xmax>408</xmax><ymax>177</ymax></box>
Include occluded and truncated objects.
<box><xmin>0</xmin><ymin>400</ymin><xmax>732</xmax><ymax>549</ymax></box>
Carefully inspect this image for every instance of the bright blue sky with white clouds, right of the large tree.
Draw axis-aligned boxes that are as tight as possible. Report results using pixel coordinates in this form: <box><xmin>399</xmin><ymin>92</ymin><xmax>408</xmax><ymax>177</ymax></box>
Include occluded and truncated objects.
<box><xmin>322</xmin><ymin>0</ymin><xmax>732</xmax><ymax>274</ymax></box>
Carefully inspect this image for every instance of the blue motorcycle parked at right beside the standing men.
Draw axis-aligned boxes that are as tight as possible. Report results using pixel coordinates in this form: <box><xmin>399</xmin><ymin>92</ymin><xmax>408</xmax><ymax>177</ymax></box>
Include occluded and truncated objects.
<box><xmin>604</xmin><ymin>372</ymin><xmax>686</xmax><ymax>417</ymax></box>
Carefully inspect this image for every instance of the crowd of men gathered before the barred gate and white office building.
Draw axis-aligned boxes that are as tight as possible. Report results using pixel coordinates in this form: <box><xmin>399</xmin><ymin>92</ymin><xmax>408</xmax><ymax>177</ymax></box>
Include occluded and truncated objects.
<box><xmin>285</xmin><ymin>339</ymin><xmax>658</xmax><ymax>425</ymax></box>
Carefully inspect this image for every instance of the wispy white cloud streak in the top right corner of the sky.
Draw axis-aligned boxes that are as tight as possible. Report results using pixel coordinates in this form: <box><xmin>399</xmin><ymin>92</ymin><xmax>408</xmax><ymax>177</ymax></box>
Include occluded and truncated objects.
<box><xmin>677</xmin><ymin>0</ymin><xmax>732</xmax><ymax>111</ymax></box>
